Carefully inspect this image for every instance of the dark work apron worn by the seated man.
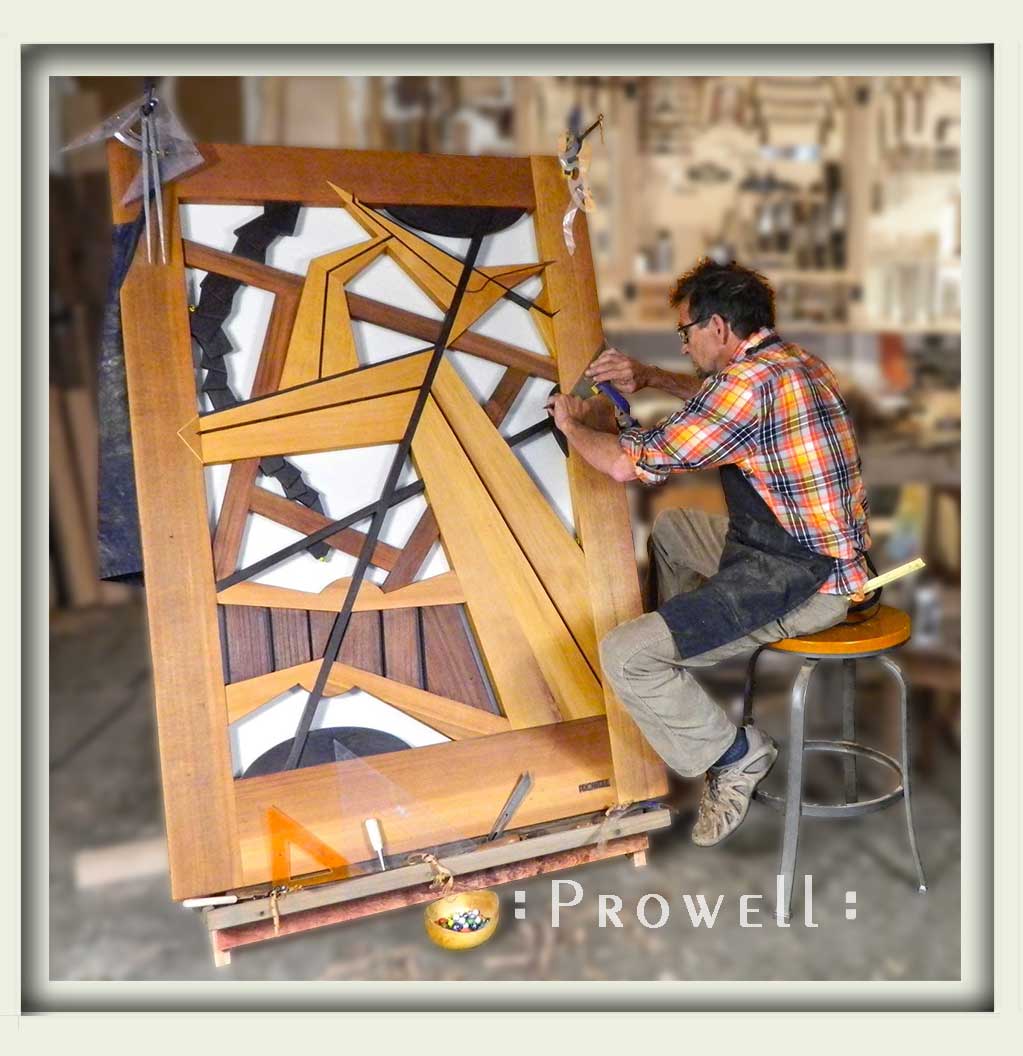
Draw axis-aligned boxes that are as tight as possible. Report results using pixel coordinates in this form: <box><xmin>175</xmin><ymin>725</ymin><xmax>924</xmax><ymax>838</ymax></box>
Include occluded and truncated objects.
<box><xmin>658</xmin><ymin>335</ymin><xmax>837</xmax><ymax>657</ymax></box>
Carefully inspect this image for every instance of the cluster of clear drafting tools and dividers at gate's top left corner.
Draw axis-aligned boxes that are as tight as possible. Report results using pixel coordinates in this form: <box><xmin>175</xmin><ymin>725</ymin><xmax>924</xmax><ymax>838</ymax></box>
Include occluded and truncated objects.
<box><xmin>63</xmin><ymin>77</ymin><xmax>206</xmax><ymax>264</ymax></box>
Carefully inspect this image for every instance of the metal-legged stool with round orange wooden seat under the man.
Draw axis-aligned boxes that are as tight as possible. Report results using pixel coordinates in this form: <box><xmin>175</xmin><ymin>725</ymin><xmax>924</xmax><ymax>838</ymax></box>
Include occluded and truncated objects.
<box><xmin>743</xmin><ymin>605</ymin><xmax>927</xmax><ymax>920</ymax></box>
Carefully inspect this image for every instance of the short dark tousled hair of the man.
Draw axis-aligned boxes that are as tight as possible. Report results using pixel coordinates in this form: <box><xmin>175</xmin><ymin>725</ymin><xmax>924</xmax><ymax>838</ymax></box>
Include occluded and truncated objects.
<box><xmin>668</xmin><ymin>257</ymin><xmax>774</xmax><ymax>338</ymax></box>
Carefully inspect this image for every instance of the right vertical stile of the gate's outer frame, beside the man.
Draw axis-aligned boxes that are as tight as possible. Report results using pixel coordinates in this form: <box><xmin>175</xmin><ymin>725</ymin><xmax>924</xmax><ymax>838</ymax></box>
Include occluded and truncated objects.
<box><xmin>532</xmin><ymin>157</ymin><xmax>667</xmax><ymax>804</ymax></box>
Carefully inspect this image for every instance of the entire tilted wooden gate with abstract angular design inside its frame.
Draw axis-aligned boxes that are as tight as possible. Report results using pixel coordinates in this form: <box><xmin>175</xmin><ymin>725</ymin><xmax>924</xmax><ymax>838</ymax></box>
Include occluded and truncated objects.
<box><xmin>111</xmin><ymin>147</ymin><xmax>663</xmax><ymax>897</ymax></box>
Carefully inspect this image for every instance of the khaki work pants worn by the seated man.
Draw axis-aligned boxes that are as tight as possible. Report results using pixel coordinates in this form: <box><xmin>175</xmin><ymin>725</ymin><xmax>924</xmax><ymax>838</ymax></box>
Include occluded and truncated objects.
<box><xmin>601</xmin><ymin>510</ymin><xmax>849</xmax><ymax>777</ymax></box>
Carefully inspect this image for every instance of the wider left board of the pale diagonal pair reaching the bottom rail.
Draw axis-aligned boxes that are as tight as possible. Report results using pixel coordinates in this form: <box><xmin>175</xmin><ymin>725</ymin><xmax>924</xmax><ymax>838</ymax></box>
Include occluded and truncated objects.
<box><xmin>405</xmin><ymin>398</ymin><xmax>604</xmax><ymax>727</ymax></box>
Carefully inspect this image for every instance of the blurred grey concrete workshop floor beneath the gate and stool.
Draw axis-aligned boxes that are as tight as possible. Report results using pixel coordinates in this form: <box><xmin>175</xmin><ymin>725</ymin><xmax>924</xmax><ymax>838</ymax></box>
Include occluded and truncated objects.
<box><xmin>50</xmin><ymin>605</ymin><xmax>960</xmax><ymax>980</ymax></box>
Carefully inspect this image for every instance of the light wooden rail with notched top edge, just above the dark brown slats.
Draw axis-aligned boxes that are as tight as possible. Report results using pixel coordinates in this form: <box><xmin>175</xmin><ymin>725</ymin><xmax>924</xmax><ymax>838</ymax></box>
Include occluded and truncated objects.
<box><xmin>216</xmin><ymin>572</ymin><xmax>466</xmax><ymax>612</ymax></box>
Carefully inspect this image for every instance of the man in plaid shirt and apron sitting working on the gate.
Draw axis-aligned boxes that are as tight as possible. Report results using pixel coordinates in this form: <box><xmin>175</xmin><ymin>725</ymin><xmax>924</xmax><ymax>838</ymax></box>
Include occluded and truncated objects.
<box><xmin>549</xmin><ymin>260</ymin><xmax>870</xmax><ymax>847</ymax></box>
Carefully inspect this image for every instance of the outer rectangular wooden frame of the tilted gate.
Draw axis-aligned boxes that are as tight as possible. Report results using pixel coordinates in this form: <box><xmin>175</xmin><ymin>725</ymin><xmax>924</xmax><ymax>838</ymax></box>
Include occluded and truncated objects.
<box><xmin>109</xmin><ymin>142</ymin><xmax>666</xmax><ymax>899</ymax></box>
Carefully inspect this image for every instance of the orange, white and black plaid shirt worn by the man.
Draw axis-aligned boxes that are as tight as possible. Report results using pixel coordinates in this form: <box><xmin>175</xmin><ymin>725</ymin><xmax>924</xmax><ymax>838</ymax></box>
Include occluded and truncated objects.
<box><xmin>619</xmin><ymin>329</ymin><xmax>870</xmax><ymax>595</ymax></box>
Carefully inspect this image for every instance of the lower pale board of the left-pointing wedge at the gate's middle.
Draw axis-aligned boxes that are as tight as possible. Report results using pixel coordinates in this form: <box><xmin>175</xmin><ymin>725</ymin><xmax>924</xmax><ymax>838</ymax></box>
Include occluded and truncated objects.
<box><xmin>203</xmin><ymin>392</ymin><xmax>416</xmax><ymax>466</ymax></box>
